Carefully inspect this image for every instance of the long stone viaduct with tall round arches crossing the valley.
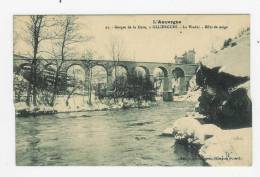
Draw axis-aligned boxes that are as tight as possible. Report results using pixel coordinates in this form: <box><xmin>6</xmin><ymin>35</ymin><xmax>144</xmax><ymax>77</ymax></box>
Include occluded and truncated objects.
<box><xmin>14</xmin><ymin>55</ymin><xmax>198</xmax><ymax>101</ymax></box>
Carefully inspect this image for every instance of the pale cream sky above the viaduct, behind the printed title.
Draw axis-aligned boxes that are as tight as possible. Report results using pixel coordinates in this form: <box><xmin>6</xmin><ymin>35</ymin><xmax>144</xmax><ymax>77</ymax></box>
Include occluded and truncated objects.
<box><xmin>14</xmin><ymin>15</ymin><xmax>250</xmax><ymax>62</ymax></box>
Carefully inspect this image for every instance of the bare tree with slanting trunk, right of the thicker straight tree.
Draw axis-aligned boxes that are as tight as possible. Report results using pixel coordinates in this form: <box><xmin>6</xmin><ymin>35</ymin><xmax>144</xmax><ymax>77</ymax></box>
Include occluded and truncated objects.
<box><xmin>51</xmin><ymin>16</ymin><xmax>91</xmax><ymax>106</ymax></box>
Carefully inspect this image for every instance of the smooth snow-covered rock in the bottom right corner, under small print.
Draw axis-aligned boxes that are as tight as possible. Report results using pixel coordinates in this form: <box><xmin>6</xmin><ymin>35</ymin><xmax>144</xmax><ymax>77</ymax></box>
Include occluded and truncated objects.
<box><xmin>199</xmin><ymin>128</ymin><xmax>252</xmax><ymax>166</ymax></box>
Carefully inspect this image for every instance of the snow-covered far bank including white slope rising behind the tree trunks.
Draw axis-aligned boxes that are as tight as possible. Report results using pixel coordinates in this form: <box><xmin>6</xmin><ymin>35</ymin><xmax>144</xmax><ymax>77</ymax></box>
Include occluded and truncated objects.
<box><xmin>15</xmin><ymin>95</ymin><xmax>156</xmax><ymax>114</ymax></box>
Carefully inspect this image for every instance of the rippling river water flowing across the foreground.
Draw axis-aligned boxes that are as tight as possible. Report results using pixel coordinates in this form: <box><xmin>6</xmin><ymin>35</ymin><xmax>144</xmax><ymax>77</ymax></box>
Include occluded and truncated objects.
<box><xmin>16</xmin><ymin>102</ymin><xmax>203</xmax><ymax>166</ymax></box>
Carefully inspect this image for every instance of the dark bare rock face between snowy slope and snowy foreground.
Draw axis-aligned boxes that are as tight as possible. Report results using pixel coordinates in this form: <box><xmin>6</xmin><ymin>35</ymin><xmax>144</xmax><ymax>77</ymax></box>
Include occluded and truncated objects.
<box><xmin>196</xmin><ymin>64</ymin><xmax>252</xmax><ymax>128</ymax></box>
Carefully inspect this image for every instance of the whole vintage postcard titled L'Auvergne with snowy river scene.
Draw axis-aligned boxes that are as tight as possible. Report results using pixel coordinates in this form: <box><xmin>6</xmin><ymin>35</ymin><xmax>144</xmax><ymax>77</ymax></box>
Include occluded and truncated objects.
<box><xmin>13</xmin><ymin>14</ymin><xmax>252</xmax><ymax>166</ymax></box>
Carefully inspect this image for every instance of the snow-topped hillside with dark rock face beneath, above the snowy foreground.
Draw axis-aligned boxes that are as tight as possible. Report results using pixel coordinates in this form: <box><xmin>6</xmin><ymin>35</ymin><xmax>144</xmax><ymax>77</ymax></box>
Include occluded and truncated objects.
<box><xmin>196</xmin><ymin>28</ymin><xmax>252</xmax><ymax>128</ymax></box>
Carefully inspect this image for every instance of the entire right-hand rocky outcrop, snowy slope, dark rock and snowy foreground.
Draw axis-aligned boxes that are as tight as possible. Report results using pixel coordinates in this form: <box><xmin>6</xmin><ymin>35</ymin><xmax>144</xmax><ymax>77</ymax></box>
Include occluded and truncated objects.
<box><xmin>163</xmin><ymin>28</ymin><xmax>252</xmax><ymax>166</ymax></box>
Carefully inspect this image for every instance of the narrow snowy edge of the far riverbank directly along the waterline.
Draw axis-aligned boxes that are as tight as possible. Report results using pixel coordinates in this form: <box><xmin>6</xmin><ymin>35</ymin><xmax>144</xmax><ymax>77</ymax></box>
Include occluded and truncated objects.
<box><xmin>15</xmin><ymin>99</ymin><xmax>157</xmax><ymax>116</ymax></box>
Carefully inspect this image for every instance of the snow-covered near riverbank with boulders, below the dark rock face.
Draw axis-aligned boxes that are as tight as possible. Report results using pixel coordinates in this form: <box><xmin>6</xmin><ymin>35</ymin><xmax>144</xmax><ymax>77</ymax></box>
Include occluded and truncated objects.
<box><xmin>162</xmin><ymin>116</ymin><xmax>252</xmax><ymax>166</ymax></box>
